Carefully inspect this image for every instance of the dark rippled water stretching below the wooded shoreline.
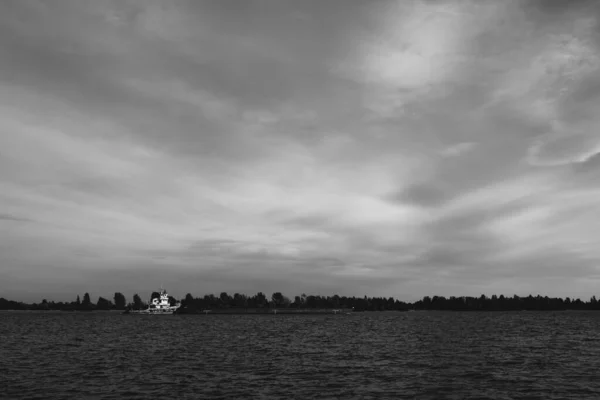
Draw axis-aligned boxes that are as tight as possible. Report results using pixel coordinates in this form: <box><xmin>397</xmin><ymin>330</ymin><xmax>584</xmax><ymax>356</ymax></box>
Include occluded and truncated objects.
<box><xmin>0</xmin><ymin>312</ymin><xmax>600</xmax><ymax>399</ymax></box>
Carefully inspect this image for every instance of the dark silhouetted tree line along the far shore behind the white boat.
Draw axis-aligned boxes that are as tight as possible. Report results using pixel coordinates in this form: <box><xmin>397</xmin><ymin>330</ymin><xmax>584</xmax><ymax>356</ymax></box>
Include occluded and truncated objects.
<box><xmin>0</xmin><ymin>292</ymin><xmax>600</xmax><ymax>311</ymax></box>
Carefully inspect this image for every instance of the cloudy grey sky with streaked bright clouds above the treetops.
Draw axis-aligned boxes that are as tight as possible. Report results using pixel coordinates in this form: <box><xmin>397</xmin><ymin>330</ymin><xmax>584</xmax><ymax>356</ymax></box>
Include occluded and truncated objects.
<box><xmin>0</xmin><ymin>0</ymin><xmax>600</xmax><ymax>301</ymax></box>
